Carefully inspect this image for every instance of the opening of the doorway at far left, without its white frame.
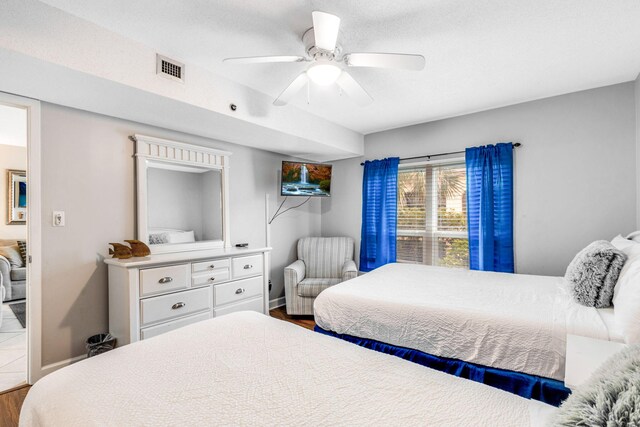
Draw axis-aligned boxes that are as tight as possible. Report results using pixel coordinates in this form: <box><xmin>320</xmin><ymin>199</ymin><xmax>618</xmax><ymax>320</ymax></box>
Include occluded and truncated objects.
<box><xmin>0</xmin><ymin>103</ymin><xmax>29</xmax><ymax>391</ymax></box>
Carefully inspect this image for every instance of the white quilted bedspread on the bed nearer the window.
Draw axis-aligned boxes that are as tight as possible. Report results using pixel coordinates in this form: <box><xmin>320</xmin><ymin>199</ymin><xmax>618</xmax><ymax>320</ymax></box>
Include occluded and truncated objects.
<box><xmin>314</xmin><ymin>264</ymin><xmax>609</xmax><ymax>380</ymax></box>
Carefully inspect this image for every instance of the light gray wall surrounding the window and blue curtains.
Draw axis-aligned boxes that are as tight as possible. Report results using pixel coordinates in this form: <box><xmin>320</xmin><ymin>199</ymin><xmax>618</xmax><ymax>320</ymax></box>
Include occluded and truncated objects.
<box><xmin>322</xmin><ymin>82</ymin><xmax>637</xmax><ymax>275</ymax></box>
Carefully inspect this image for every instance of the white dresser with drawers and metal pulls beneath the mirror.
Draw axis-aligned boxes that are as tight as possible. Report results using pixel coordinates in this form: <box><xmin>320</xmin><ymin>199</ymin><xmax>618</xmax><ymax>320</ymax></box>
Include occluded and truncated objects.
<box><xmin>105</xmin><ymin>248</ymin><xmax>271</xmax><ymax>345</ymax></box>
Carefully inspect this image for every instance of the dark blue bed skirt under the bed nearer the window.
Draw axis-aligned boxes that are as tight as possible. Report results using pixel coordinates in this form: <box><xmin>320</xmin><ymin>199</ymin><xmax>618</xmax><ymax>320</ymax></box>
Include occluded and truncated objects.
<box><xmin>315</xmin><ymin>326</ymin><xmax>571</xmax><ymax>406</ymax></box>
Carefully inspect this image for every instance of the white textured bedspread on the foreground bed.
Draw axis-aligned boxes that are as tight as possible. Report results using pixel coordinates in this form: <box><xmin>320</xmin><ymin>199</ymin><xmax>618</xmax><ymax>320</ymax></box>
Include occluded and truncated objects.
<box><xmin>20</xmin><ymin>312</ymin><xmax>555</xmax><ymax>427</ymax></box>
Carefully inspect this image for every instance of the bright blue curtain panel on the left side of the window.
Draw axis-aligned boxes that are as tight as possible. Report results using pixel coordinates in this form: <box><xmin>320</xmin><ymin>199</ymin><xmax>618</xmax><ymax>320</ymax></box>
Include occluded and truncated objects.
<box><xmin>360</xmin><ymin>157</ymin><xmax>400</xmax><ymax>271</ymax></box>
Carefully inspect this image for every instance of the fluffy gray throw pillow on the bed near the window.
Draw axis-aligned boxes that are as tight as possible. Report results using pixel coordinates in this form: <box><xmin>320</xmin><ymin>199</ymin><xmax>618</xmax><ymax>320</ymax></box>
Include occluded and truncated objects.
<box><xmin>564</xmin><ymin>240</ymin><xmax>627</xmax><ymax>308</ymax></box>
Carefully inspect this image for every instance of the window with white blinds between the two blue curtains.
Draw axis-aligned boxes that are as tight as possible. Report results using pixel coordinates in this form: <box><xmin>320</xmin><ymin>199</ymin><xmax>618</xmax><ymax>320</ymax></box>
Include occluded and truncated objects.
<box><xmin>396</xmin><ymin>161</ymin><xmax>469</xmax><ymax>268</ymax></box>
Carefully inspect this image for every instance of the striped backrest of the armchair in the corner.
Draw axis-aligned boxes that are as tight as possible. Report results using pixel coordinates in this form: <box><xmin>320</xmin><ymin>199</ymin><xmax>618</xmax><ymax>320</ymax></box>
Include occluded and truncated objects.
<box><xmin>298</xmin><ymin>237</ymin><xmax>354</xmax><ymax>279</ymax></box>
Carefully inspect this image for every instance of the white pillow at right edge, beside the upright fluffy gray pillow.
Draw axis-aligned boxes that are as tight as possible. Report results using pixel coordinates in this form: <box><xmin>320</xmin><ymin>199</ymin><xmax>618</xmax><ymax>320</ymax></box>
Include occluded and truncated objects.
<box><xmin>613</xmin><ymin>245</ymin><xmax>640</xmax><ymax>344</ymax></box>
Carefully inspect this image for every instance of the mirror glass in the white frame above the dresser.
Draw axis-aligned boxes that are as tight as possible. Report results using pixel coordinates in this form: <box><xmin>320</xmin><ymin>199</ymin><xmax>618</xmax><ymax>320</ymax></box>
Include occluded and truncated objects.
<box><xmin>147</xmin><ymin>164</ymin><xmax>222</xmax><ymax>245</ymax></box>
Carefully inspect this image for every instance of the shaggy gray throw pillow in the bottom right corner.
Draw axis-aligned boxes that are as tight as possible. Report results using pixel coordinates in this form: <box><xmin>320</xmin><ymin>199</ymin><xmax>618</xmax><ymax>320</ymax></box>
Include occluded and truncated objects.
<box><xmin>553</xmin><ymin>345</ymin><xmax>640</xmax><ymax>427</ymax></box>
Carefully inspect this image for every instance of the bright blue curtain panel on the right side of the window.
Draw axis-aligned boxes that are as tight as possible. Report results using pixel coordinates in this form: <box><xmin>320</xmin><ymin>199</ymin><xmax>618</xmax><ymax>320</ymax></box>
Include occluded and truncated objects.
<box><xmin>465</xmin><ymin>142</ymin><xmax>513</xmax><ymax>273</ymax></box>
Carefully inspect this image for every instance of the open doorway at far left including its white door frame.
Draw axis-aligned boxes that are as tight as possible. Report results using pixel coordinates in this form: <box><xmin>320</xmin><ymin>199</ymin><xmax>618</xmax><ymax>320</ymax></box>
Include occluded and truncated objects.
<box><xmin>0</xmin><ymin>92</ymin><xmax>45</xmax><ymax>392</ymax></box>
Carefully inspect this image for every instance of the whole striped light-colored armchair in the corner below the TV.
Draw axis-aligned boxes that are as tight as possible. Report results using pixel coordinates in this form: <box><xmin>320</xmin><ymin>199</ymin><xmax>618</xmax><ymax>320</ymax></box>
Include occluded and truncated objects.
<box><xmin>284</xmin><ymin>237</ymin><xmax>358</xmax><ymax>314</ymax></box>
